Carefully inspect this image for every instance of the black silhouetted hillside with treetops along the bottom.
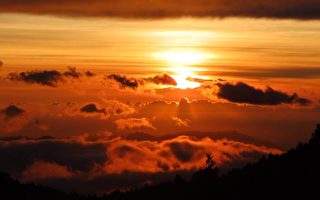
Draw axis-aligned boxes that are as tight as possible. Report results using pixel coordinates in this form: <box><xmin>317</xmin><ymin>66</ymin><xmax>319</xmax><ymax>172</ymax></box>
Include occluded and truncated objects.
<box><xmin>0</xmin><ymin>125</ymin><xmax>320</xmax><ymax>200</ymax></box>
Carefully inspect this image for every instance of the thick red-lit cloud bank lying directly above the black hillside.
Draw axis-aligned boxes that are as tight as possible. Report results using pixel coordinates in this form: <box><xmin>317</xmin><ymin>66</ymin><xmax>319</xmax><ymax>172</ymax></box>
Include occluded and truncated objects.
<box><xmin>0</xmin><ymin>134</ymin><xmax>281</xmax><ymax>192</ymax></box>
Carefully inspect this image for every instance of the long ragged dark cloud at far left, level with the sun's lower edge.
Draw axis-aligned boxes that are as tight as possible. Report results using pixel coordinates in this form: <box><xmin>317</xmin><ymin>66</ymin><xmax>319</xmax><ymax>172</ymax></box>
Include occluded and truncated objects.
<box><xmin>7</xmin><ymin>67</ymin><xmax>93</xmax><ymax>87</ymax></box>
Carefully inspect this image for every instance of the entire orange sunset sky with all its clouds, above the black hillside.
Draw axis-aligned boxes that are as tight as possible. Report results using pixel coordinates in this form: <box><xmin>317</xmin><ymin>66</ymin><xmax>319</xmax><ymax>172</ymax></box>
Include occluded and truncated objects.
<box><xmin>0</xmin><ymin>0</ymin><xmax>320</xmax><ymax>193</ymax></box>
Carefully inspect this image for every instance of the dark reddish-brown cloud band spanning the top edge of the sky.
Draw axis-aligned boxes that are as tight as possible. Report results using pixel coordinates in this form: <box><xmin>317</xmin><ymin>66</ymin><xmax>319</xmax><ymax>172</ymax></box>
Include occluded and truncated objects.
<box><xmin>0</xmin><ymin>0</ymin><xmax>320</xmax><ymax>19</ymax></box>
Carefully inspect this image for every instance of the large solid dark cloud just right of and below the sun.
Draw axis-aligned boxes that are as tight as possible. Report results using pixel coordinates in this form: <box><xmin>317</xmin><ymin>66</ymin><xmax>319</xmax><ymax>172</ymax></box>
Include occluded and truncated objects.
<box><xmin>216</xmin><ymin>82</ymin><xmax>311</xmax><ymax>106</ymax></box>
